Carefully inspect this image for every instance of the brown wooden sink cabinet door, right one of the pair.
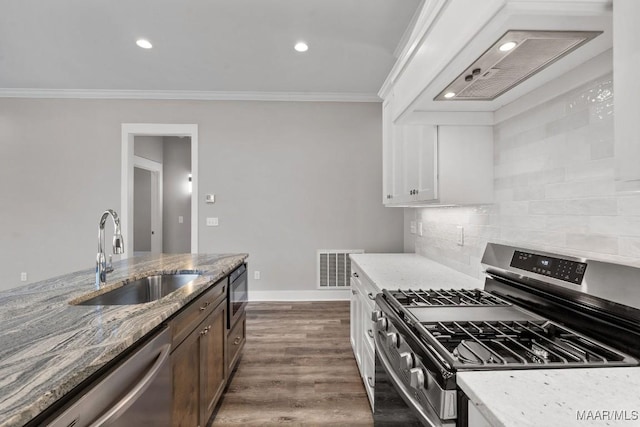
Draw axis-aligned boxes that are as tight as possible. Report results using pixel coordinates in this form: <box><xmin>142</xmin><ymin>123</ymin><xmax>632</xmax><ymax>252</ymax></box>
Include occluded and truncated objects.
<box><xmin>200</xmin><ymin>301</ymin><xmax>227</xmax><ymax>426</ymax></box>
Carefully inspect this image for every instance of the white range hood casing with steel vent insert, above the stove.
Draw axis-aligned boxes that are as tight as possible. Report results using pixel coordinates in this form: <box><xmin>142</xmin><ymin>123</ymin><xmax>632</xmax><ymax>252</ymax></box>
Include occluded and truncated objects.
<box><xmin>378</xmin><ymin>0</ymin><xmax>613</xmax><ymax>125</ymax></box>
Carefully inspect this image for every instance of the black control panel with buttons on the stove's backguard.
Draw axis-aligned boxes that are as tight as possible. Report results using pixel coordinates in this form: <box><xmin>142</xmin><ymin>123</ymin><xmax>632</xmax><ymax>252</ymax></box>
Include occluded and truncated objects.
<box><xmin>510</xmin><ymin>251</ymin><xmax>587</xmax><ymax>285</ymax></box>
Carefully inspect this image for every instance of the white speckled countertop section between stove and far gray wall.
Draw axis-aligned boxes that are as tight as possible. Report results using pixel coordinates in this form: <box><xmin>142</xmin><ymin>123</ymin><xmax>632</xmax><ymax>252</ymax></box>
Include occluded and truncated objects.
<box><xmin>349</xmin><ymin>254</ymin><xmax>484</xmax><ymax>290</ymax></box>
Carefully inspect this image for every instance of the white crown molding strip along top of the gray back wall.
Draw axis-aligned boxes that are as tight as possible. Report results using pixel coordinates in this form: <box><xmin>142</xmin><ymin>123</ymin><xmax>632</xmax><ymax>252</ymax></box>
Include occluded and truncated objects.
<box><xmin>0</xmin><ymin>88</ymin><xmax>381</xmax><ymax>102</ymax></box>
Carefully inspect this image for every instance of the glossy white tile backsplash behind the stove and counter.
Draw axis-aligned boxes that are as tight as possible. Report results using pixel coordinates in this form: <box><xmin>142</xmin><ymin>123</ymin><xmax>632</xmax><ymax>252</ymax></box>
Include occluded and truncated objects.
<box><xmin>411</xmin><ymin>75</ymin><xmax>640</xmax><ymax>277</ymax></box>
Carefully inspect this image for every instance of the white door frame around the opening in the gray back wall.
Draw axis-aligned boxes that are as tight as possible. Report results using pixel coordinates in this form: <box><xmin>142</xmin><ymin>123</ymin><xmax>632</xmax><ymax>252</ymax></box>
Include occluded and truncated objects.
<box><xmin>120</xmin><ymin>123</ymin><xmax>198</xmax><ymax>259</ymax></box>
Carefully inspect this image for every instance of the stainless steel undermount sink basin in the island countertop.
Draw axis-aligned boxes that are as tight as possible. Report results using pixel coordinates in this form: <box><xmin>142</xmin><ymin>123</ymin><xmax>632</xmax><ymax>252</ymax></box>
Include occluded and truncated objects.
<box><xmin>75</xmin><ymin>274</ymin><xmax>201</xmax><ymax>305</ymax></box>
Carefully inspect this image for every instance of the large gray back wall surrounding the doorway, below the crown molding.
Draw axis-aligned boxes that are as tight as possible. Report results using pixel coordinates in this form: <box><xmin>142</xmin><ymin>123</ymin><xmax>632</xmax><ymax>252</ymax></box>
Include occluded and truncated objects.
<box><xmin>0</xmin><ymin>99</ymin><xmax>403</xmax><ymax>291</ymax></box>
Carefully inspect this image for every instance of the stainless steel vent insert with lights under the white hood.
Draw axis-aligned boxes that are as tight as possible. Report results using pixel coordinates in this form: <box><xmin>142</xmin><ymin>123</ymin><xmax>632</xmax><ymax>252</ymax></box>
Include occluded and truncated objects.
<box><xmin>434</xmin><ymin>30</ymin><xmax>602</xmax><ymax>101</ymax></box>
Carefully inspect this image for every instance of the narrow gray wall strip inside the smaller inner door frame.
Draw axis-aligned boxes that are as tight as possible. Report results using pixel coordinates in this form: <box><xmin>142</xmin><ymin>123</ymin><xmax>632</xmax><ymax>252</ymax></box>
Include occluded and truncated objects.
<box><xmin>133</xmin><ymin>168</ymin><xmax>151</xmax><ymax>252</ymax></box>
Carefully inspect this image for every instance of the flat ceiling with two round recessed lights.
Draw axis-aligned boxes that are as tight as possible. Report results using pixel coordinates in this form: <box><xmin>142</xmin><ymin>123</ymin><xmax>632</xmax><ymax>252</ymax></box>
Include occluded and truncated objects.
<box><xmin>0</xmin><ymin>0</ymin><xmax>421</xmax><ymax>96</ymax></box>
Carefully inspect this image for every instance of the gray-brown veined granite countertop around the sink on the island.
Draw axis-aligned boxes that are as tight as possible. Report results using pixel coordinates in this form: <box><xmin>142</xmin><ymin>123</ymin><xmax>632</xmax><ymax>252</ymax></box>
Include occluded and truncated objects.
<box><xmin>0</xmin><ymin>254</ymin><xmax>248</xmax><ymax>427</ymax></box>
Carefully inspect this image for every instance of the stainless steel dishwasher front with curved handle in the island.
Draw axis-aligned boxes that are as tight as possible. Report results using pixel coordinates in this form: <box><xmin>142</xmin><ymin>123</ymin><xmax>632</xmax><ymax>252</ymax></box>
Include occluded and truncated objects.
<box><xmin>45</xmin><ymin>328</ymin><xmax>172</xmax><ymax>427</ymax></box>
